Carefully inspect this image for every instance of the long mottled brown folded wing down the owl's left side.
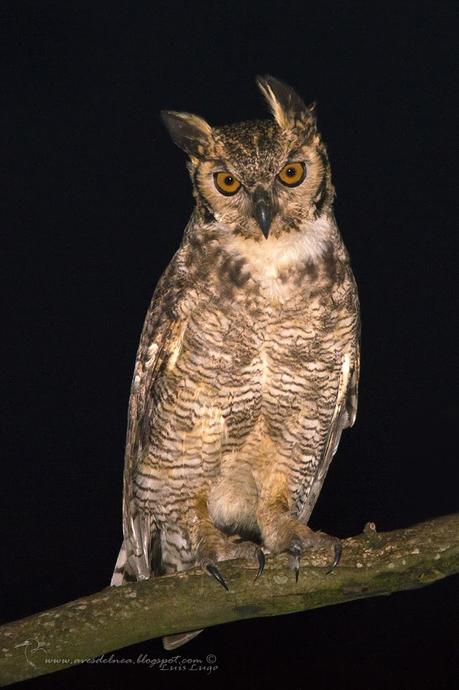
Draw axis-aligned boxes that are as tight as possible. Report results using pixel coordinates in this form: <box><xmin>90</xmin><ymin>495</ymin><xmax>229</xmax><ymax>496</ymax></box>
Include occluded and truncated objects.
<box><xmin>111</xmin><ymin>254</ymin><xmax>190</xmax><ymax>585</ymax></box>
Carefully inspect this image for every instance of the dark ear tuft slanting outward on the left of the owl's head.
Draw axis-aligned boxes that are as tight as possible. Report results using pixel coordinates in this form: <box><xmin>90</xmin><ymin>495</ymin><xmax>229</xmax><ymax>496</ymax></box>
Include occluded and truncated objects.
<box><xmin>161</xmin><ymin>110</ymin><xmax>212</xmax><ymax>158</ymax></box>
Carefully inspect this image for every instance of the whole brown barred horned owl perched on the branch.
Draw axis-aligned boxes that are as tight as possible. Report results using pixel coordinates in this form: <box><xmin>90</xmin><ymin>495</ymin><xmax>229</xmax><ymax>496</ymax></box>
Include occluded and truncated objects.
<box><xmin>112</xmin><ymin>76</ymin><xmax>359</xmax><ymax>649</ymax></box>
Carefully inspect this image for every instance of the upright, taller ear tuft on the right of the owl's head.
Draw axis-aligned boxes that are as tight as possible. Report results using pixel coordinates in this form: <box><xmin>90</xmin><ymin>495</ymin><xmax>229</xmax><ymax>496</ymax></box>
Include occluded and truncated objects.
<box><xmin>257</xmin><ymin>75</ymin><xmax>316</xmax><ymax>129</ymax></box>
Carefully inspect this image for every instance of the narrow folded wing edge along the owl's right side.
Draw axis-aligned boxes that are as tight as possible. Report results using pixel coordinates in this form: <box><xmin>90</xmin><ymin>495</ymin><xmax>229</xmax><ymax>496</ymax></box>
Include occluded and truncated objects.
<box><xmin>298</xmin><ymin>340</ymin><xmax>360</xmax><ymax>522</ymax></box>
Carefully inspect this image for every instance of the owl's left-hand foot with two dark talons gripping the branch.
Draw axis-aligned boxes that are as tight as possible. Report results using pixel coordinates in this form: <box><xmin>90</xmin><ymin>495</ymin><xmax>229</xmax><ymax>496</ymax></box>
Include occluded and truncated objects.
<box><xmin>196</xmin><ymin>538</ymin><xmax>265</xmax><ymax>591</ymax></box>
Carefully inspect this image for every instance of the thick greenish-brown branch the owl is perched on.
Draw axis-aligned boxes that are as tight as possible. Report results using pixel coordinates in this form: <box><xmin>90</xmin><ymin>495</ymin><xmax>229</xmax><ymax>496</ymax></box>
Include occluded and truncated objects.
<box><xmin>0</xmin><ymin>514</ymin><xmax>459</xmax><ymax>686</ymax></box>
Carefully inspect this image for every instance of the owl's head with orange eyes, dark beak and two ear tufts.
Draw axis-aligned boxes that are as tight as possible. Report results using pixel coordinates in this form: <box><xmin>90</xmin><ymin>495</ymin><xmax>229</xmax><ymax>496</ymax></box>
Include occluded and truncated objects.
<box><xmin>161</xmin><ymin>76</ymin><xmax>334</xmax><ymax>241</ymax></box>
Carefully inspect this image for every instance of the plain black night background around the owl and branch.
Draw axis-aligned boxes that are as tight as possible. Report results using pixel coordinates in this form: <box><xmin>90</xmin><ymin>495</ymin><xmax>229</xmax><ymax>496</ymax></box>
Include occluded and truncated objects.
<box><xmin>0</xmin><ymin>0</ymin><xmax>459</xmax><ymax>690</ymax></box>
